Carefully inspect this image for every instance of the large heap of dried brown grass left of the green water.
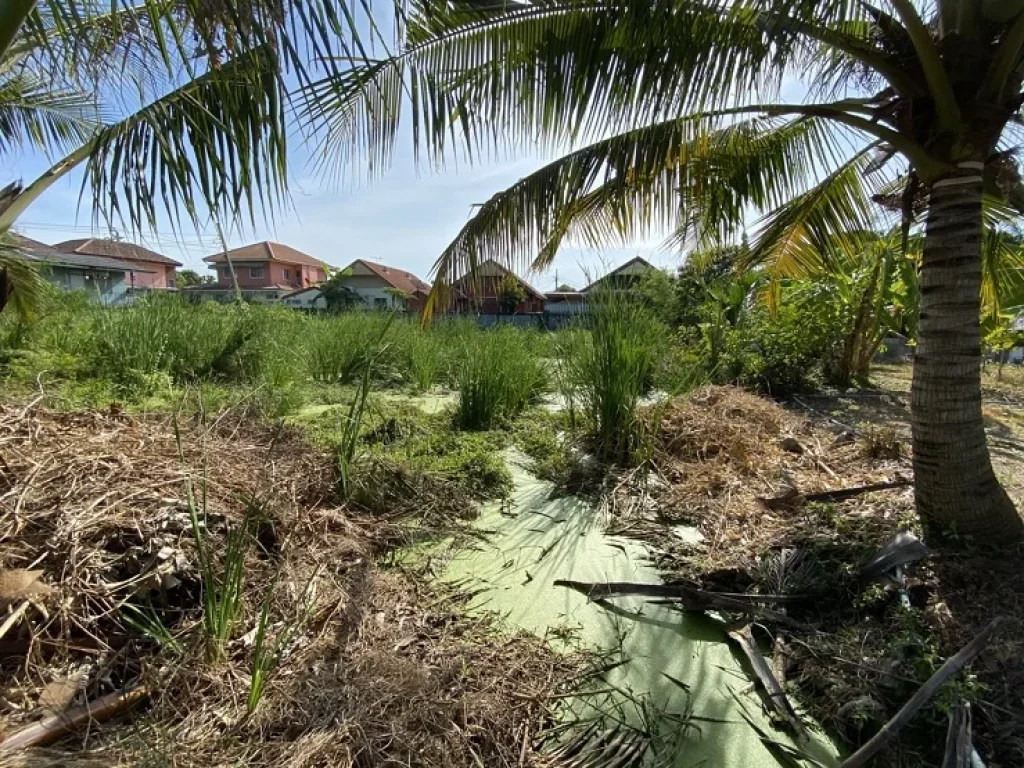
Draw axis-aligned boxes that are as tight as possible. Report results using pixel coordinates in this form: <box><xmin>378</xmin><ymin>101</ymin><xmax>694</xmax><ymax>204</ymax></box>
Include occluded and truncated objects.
<box><xmin>0</xmin><ymin>404</ymin><xmax>573</xmax><ymax>766</ymax></box>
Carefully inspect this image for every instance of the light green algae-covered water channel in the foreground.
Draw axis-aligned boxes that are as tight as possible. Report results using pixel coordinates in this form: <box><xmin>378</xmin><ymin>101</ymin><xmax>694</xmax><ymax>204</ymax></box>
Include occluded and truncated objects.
<box><xmin>444</xmin><ymin>455</ymin><xmax>836</xmax><ymax>768</ymax></box>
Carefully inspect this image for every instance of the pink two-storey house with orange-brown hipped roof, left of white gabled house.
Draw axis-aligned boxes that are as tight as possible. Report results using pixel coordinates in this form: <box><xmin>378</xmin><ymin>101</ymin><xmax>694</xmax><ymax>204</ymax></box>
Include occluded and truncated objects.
<box><xmin>183</xmin><ymin>241</ymin><xmax>327</xmax><ymax>302</ymax></box>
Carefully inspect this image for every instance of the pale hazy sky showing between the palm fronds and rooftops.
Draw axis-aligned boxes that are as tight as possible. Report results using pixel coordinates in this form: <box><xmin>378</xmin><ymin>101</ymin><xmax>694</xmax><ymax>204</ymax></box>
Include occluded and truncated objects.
<box><xmin>8</xmin><ymin>121</ymin><xmax>680</xmax><ymax>291</ymax></box>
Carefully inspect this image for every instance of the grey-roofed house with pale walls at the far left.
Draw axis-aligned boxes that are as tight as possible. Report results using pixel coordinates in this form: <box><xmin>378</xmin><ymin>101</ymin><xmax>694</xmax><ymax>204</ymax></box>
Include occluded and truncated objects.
<box><xmin>10</xmin><ymin>234</ymin><xmax>155</xmax><ymax>304</ymax></box>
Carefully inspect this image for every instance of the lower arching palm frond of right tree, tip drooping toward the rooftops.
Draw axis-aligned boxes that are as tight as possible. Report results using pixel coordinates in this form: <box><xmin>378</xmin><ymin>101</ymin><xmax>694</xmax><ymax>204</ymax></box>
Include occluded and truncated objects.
<box><xmin>419</xmin><ymin>117</ymin><xmax>851</xmax><ymax>319</ymax></box>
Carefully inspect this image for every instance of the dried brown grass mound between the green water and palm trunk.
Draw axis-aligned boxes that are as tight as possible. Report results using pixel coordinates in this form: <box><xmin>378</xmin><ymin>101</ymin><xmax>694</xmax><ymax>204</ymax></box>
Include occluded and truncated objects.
<box><xmin>643</xmin><ymin>386</ymin><xmax>910</xmax><ymax>572</ymax></box>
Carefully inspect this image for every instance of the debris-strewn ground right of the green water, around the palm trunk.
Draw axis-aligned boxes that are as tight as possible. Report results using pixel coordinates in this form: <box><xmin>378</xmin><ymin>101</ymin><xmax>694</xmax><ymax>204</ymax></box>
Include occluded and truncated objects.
<box><xmin>634</xmin><ymin>376</ymin><xmax>1024</xmax><ymax>767</ymax></box>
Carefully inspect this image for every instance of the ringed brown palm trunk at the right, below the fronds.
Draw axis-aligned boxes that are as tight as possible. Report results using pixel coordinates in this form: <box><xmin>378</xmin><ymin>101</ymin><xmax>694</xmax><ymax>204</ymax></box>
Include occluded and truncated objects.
<box><xmin>911</xmin><ymin>162</ymin><xmax>1024</xmax><ymax>543</ymax></box>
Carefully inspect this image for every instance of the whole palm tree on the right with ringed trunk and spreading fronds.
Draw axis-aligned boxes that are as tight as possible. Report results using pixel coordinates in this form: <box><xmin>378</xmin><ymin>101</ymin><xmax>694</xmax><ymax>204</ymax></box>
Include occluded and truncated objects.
<box><xmin>310</xmin><ymin>0</ymin><xmax>1024</xmax><ymax>542</ymax></box>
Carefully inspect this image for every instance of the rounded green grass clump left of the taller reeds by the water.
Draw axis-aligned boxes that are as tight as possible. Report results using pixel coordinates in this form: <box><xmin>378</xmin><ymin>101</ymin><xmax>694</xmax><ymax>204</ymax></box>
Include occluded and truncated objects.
<box><xmin>455</xmin><ymin>326</ymin><xmax>547</xmax><ymax>430</ymax></box>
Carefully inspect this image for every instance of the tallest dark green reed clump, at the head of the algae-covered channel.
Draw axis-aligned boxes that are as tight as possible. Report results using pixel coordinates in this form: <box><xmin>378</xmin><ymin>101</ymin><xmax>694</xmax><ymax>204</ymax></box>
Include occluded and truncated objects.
<box><xmin>558</xmin><ymin>291</ymin><xmax>668</xmax><ymax>462</ymax></box>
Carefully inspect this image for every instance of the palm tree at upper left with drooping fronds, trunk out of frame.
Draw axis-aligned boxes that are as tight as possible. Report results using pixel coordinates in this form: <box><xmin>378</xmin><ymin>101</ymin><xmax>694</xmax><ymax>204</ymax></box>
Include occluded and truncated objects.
<box><xmin>0</xmin><ymin>0</ymin><xmax>358</xmax><ymax>311</ymax></box>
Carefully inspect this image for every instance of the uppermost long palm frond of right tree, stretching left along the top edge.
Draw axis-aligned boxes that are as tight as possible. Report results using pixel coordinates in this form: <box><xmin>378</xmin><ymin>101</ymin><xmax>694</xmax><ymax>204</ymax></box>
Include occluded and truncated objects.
<box><xmin>300</xmin><ymin>0</ymin><xmax>884</xmax><ymax>174</ymax></box>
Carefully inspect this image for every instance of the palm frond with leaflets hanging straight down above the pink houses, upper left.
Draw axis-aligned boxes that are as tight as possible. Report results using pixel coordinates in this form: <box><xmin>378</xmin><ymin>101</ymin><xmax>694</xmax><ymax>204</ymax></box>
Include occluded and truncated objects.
<box><xmin>83</xmin><ymin>50</ymin><xmax>287</xmax><ymax>230</ymax></box>
